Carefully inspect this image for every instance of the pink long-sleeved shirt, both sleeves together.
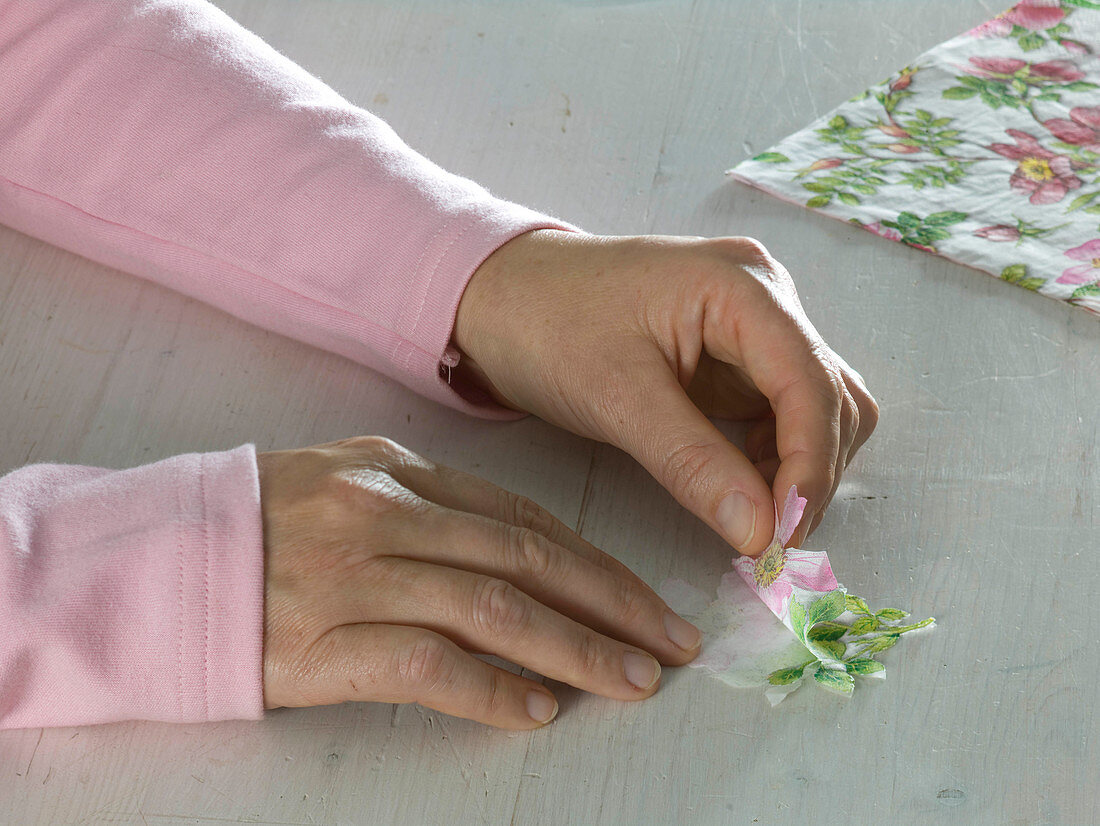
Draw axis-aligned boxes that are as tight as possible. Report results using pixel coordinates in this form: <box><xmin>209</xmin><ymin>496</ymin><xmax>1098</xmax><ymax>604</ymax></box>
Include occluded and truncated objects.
<box><xmin>0</xmin><ymin>0</ymin><xmax>574</xmax><ymax>728</ymax></box>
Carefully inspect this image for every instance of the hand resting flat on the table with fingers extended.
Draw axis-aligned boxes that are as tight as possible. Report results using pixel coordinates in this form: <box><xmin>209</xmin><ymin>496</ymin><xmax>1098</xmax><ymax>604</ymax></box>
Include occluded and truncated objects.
<box><xmin>257</xmin><ymin>437</ymin><xmax>700</xmax><ymax>729</ymax></box>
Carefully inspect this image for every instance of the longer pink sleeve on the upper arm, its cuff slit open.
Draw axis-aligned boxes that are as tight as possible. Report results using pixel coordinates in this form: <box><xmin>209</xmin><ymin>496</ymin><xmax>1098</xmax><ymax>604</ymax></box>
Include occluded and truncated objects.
<box><xmin>0</xmin><ymin>0</ymin><xmax>575</xmax><ymax>418</ymax></box>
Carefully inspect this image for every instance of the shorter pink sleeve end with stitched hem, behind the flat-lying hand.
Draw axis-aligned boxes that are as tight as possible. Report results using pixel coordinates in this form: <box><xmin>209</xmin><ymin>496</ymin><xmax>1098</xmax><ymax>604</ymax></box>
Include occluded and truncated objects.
<box><xmin>0</xmin><ymin>444</ymin><xmax>264</xmax><ymax>728</ymax></box>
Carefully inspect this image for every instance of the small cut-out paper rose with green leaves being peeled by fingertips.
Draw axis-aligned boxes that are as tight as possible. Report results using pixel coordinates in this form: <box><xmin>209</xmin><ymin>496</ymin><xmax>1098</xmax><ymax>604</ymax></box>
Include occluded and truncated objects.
<box><xmin>659</xmin><ymin>487</ymin><xmax>935</xmax><ymax>705</ymax></box>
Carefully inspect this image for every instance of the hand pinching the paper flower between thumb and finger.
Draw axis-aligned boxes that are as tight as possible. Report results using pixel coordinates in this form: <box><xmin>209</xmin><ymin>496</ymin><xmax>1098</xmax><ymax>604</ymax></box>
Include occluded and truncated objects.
<box><xmin>454</xmin><ymin>230</ymin><xmax>878</xmax><ymax>555</ymax></box>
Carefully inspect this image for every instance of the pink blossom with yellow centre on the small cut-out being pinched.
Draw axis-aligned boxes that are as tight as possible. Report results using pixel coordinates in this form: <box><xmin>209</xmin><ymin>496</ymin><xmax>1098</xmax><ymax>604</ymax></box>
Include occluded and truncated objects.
<box><xmin>734</xmin><ymin>485</ymin><xmax>839</xmax><ymax>624</ymax></box>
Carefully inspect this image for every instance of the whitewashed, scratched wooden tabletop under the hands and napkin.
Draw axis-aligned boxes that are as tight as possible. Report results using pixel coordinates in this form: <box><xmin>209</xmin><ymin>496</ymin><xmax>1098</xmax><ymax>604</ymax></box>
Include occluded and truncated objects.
<box><xmin>0</xmin><ymin>0</ymin><xmax>1100</xmax><ymax>825</ymax></box>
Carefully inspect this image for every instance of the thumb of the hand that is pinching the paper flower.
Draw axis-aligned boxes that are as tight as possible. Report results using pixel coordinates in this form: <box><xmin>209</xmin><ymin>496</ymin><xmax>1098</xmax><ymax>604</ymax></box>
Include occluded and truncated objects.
<box><xmin>608</xmin><ymin>364</ymin><xmax>776</xmax><ymax>557</ymax></box>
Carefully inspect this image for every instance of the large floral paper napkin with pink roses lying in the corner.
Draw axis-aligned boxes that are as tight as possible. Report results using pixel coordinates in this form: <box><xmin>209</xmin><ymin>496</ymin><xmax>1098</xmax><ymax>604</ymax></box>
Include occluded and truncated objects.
<box><xmin>728</xmin><ymin>0</ymin><xmax>1100</xmax><ymax>315</ymax></box>
